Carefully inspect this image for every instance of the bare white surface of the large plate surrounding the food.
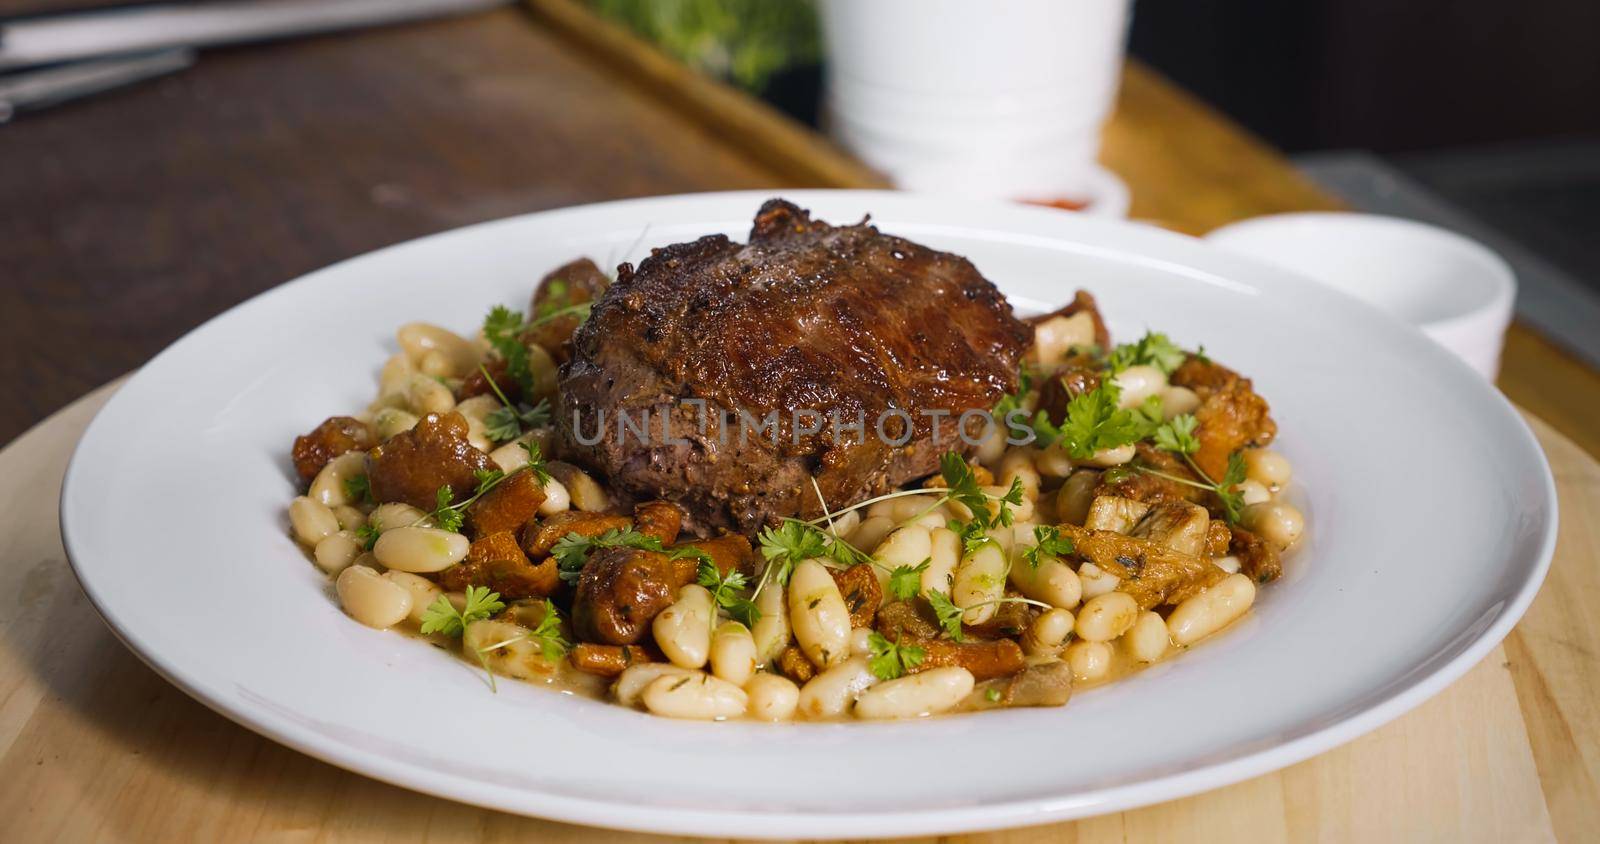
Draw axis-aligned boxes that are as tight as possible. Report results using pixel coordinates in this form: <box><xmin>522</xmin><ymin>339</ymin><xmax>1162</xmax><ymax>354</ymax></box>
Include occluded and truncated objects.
<box><xmin>61</xmin><ymin>192</ymin><xmax>1555</xmax><ymax>838</ymax></box>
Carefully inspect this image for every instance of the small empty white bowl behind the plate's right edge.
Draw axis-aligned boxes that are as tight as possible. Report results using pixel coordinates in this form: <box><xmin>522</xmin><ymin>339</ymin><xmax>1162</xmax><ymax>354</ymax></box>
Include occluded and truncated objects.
<box><xmin>1206</xmin><ymin>213</ymin><xmax>1517</xmax><ymax>380</ymax></box>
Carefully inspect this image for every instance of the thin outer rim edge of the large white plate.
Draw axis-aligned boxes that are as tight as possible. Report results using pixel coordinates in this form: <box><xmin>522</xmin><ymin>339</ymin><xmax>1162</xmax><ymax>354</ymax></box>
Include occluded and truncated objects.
<box><xmin>58</xmin><ymin>189</ymin><xmax>1560</xmax><ymax>838</ymax></box>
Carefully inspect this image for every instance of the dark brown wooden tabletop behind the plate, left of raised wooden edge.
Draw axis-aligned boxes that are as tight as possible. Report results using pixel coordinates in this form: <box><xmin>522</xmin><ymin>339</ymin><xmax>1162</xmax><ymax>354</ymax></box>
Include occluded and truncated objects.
<box><xmin>0</xmin><ymin>8</ymin><xmax>789</xmax><ymax>443</ymax></box>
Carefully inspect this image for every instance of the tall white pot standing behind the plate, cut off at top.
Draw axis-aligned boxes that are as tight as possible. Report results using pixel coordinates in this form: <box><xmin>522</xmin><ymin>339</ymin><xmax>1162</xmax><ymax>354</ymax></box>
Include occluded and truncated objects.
<box><xmin>821</xmin><ymin>0</ymin><xmax>1128</xmax><ymax>201</ymax></box>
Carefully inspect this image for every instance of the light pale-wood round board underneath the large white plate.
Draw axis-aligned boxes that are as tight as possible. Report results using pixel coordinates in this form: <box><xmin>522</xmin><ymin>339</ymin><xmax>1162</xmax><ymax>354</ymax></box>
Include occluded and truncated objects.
<box><xmin>0</xmin><ymin>385</ymin><xmax>1600</xmax><ymax>842</ymax></box>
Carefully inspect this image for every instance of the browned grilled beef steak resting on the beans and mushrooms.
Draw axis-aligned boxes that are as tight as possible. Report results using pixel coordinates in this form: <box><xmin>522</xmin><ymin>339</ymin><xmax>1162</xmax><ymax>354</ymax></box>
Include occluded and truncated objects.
<box><xmin>557</xmin><ymin>200</ymin><xmax>1029</xmax><ymax>535</ymax></box>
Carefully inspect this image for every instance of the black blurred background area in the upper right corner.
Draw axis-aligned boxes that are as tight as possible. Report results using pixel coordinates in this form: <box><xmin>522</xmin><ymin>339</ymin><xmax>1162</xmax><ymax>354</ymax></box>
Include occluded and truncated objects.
<box><xmin>1131</xmin><ymin>0</ymin><xmax>1600</xmax><ymax>152</ymax></box>
